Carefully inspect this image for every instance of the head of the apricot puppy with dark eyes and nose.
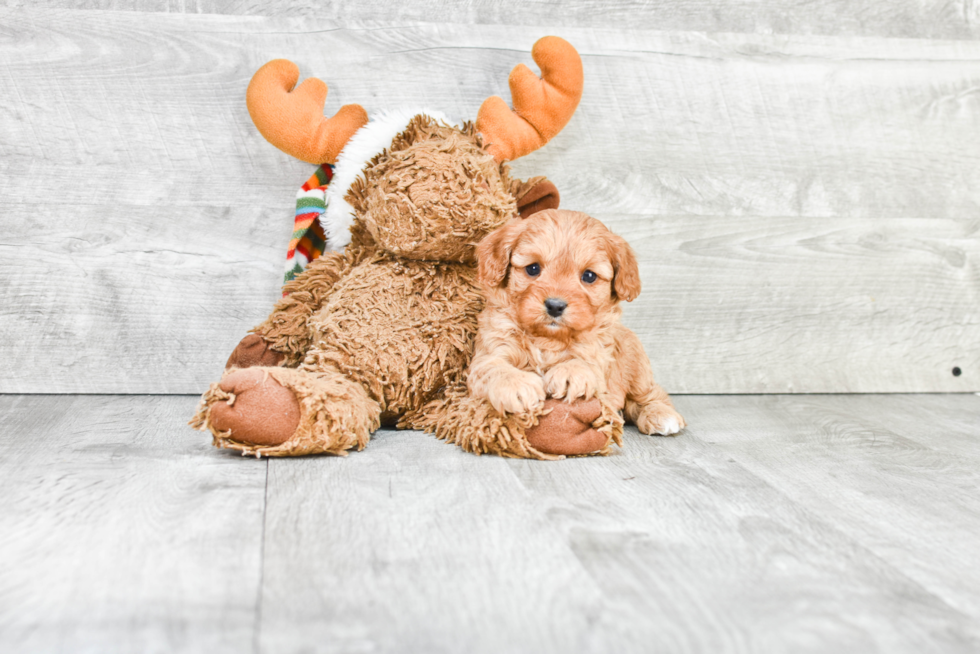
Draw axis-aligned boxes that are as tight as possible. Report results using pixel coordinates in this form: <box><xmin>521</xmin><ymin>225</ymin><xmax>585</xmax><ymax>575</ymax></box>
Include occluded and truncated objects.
<box><xmin>477</xmin><ymin>209</ymin><xmax>640</xmax><ymax>340</ymax></box>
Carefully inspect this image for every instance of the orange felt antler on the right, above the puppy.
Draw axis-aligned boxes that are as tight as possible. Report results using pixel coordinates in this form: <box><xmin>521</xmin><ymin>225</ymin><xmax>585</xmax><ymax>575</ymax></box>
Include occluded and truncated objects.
<box><xmin>476</xmin><ymin>36</ymin><xmax>582</xmax><ymax>161</ymax></box>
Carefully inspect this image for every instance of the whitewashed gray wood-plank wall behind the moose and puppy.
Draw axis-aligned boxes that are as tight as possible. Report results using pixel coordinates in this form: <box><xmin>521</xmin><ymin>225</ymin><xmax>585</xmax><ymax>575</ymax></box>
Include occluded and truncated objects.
<box><xmin>0</xmin><ymin>0</ymin><xmax>980</xmax><ymax>393</ymax></box>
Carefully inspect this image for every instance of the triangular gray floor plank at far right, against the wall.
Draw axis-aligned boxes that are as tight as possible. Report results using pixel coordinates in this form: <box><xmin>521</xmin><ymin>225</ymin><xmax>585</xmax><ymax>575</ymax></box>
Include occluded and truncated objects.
<box><xmin>676</xmin><ymin>395</ymin><xmax>980</xmax><ymax>615</ymax></box>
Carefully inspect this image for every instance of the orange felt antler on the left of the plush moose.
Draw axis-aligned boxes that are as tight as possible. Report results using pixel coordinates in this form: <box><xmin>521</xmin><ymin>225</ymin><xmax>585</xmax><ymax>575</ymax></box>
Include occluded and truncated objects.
<box><xmin>245</xmin><ymin>59</ymin><xmax>367</xmax><ymax>164</ymax></box>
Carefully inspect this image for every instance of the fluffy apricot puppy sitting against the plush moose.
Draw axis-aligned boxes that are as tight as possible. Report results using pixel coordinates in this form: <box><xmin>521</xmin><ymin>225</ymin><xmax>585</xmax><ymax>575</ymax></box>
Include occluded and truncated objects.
<box><xmin>467</xmin><ymin>209</ymin><xmax>685</xmax><ymax>435</ymax></box>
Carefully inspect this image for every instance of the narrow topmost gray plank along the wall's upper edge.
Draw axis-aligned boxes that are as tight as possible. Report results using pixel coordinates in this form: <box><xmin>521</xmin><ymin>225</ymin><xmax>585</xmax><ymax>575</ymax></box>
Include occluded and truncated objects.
<box><xmin>0</xmin><ymin>0</ymin><xmax>980</xmax><ymax>39</ymax></box>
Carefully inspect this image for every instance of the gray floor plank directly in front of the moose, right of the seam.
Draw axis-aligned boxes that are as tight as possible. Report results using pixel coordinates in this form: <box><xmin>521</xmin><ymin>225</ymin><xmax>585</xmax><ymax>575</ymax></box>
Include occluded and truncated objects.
<box><xmin>260</xmin><ymin>431</ymin><xmax>604</xmax><ymax>652</ymax></box>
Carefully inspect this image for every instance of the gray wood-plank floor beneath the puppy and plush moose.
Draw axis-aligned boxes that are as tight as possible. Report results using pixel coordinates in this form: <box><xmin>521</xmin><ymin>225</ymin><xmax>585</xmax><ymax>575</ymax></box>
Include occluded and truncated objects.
<box><xmin>0</xmin><ymin>394</ymin><xmax>980</xmax><ymax>654</ymax></box>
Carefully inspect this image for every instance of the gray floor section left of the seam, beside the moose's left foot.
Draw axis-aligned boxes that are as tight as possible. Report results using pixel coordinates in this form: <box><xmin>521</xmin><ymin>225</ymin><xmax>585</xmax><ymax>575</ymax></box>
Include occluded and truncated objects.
<box><xmin>0</xmin><ymin>396</ymin><xmax>266</xmax><ymax>652</ymax></box>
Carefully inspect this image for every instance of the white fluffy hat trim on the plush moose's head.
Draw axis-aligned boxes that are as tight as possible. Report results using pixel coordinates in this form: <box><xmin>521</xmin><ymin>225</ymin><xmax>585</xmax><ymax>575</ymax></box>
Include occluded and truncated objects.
<box><xmin>320</xmin><ymin>109</ymin><xmax>454</xmax><ymax>251</ymax></box>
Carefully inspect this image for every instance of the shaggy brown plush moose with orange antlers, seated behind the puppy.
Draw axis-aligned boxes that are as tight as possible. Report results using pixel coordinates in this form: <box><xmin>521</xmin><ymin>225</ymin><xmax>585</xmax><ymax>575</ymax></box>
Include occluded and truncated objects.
<box><xmin>191</xmin><ymin>37</ymin><xmax>622</xmax><ymax>459</ymax></box>
